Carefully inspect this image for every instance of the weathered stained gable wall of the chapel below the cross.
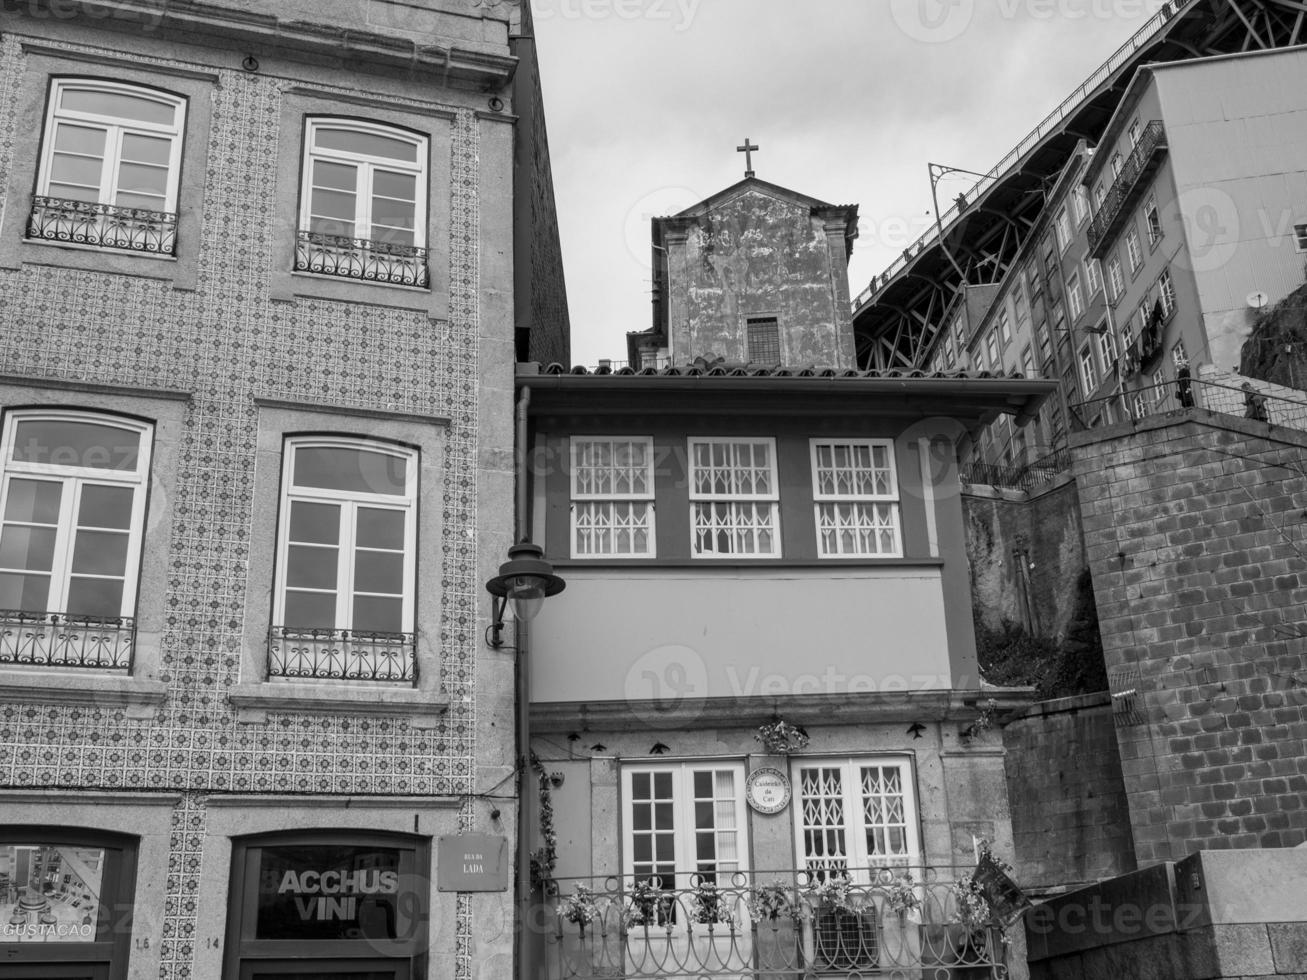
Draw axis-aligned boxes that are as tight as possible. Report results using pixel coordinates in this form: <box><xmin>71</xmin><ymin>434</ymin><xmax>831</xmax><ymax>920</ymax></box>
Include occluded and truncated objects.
<box><xmin>669</xmin><ymin>191</ymin><xmax>853</xmax><ymax>367</ymax></box>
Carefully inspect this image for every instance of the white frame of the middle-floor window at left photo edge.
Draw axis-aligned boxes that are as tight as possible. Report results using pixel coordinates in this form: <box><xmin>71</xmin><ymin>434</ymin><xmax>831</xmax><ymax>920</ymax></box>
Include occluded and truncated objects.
<box><xmin>0</xmin><ymin>409</ymin><xmax>154</xmax><ymax>618</ymax></box>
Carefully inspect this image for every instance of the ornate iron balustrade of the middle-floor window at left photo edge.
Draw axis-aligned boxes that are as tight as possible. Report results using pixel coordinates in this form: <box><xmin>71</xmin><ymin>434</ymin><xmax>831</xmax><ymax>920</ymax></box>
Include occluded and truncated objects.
<box><xmin>0</xmin><ymin>609</ymin><xmax>136</xmax><ymax>670</ymax></box>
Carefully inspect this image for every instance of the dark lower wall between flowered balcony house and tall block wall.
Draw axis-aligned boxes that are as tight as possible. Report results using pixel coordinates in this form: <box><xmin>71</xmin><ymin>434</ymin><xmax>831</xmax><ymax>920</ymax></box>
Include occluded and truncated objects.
<box><xmin>1002</xmin><ymin>691</ymin><xmax>1134</xmax><ymax>892</ymax></box>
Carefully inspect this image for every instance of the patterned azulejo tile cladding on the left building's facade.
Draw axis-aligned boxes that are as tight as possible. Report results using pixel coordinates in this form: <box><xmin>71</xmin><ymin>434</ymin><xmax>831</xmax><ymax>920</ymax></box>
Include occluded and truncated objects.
<box><xmin>0</xmin><ymin>34</ymin><xmax>507</xmax><ymax>977</ymax></box>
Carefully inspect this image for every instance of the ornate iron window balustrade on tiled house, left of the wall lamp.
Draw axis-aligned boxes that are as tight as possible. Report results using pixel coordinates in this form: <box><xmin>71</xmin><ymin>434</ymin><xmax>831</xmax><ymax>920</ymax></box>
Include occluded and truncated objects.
<box><xmin>268</xmin><ymin>626</ymin><xmax>417</xmax><ymax>683</ymax></box>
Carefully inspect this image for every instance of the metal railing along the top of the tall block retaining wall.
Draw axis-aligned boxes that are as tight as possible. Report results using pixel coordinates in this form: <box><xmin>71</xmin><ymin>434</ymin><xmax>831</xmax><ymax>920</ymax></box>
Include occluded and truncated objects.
<box><xmin>1069</xmin><ymin>378</ymin><xmax>1307</xmax><ymax>431</ymax></box>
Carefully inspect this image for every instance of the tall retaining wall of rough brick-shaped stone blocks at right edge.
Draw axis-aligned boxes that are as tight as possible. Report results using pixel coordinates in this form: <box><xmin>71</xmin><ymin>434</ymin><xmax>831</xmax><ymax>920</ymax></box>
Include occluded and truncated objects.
<box><xmin>1073</xmin><ymin>410</ymin><xmax>1307</xmax><ymax>865</ymax></box>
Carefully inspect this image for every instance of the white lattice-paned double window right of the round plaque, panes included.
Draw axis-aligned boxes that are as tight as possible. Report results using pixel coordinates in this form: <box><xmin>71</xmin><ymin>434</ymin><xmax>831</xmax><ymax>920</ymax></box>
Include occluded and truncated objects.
<box><xmin>793</xmin><ymin>758</ymin><xmax>920</xmax><ymax>883</ymax></box>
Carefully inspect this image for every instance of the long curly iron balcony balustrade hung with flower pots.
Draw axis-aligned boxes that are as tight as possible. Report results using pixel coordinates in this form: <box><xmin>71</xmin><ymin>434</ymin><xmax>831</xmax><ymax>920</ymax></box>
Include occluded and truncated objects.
<box><xmin>537</xmin><ymin>868</ymin><xmax>1008</xmax><ymax>980</ymax></box>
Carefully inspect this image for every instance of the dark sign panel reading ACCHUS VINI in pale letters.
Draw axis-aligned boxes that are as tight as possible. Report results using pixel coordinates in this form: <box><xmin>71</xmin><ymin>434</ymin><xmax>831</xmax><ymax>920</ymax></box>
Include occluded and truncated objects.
<box><xmin>255</xmin><ymin>844</ymin><xmax>408</xmax><ymax>939</ymax></box>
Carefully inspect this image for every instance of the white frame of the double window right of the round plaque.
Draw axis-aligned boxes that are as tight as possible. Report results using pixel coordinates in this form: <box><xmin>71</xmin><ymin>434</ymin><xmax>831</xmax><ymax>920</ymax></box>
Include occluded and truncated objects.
<box><xmin>789</xmin><ymin>755</ymin><xmax>921</xmax><ymax>885</ymax></box>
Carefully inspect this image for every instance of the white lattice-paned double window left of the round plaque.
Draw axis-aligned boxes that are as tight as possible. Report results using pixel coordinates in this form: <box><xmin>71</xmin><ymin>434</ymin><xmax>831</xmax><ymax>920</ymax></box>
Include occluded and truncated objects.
<box><xmin>622</xmin><ymin>763</ymin><xmax>749</xmax><ymax>917</ymax></box>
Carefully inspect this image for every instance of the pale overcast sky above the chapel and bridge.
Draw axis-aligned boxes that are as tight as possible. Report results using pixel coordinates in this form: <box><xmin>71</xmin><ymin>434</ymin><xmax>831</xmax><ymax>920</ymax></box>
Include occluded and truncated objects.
<box><xmin>532</xmin><ymin>0</ymin><xmax>1161</xmax><ymax>366</ymax></box>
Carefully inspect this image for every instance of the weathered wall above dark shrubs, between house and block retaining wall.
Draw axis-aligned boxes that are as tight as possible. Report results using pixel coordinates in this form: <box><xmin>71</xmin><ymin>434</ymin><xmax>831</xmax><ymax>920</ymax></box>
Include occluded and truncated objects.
<box><xmin>962</xmin><ymin>481</ymin><xmax>1085</xmax><ymax>639</ymax></box>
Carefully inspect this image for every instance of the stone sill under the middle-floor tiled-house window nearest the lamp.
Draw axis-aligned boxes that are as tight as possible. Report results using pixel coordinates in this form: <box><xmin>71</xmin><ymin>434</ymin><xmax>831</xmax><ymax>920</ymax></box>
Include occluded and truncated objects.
<box><xmin>227</xmin><ymin>681</ymin><xmax>450</xmax><ymax>728</ymax></box>
